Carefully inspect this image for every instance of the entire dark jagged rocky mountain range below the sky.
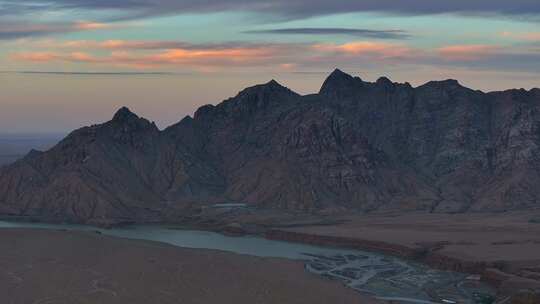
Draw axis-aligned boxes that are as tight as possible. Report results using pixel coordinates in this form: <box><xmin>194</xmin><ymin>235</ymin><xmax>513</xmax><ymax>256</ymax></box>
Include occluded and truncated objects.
<box><xmin>0</xmin><ymin>70</ymin><xmax>540</xmax><ymax>222</ymax></box>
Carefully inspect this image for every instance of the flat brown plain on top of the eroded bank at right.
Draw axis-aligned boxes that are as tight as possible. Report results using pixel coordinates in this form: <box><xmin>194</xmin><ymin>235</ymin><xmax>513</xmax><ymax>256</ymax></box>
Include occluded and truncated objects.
<box><xmin>283</xmin><ymin>211</ymin><xmax>540</xmax><ymax>266</ymax></box>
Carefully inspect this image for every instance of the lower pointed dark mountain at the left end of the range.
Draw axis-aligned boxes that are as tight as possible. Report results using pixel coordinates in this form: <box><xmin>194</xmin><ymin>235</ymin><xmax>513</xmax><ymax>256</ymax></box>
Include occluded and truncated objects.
<box><xmin>0</xmin><ymin>108</ymin><xmax>223</xmax><ymax>222</ymax></box>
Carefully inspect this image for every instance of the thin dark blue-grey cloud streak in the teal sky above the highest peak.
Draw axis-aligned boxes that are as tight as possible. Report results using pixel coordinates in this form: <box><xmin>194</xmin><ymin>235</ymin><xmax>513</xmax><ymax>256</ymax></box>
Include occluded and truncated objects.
<box><xmin>244</xmin><ymin>28</ymin><xmax>410</xmax><ymax>39</ymax></box>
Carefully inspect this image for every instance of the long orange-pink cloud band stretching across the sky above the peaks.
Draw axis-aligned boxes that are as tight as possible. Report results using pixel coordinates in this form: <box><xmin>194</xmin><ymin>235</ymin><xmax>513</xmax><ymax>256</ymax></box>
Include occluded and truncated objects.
<box><xmin>10</xmin><ymin>40</ymin><xmax>540</xmax><ymax>72</ymax></box>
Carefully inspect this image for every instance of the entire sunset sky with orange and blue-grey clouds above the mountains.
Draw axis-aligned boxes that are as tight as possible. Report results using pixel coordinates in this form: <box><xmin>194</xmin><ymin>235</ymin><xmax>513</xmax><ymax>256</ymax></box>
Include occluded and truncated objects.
<box><xmin>0</xmin><ymin>0</ymin><xmax>540</xmax><ymax>133</ymax></box>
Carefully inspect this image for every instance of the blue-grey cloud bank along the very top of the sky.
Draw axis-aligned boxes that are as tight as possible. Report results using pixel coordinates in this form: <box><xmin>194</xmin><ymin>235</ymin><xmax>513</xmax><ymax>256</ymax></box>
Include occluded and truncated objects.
<box><xmin>0</xmin><ymin>0</ymin><xmax>540</xmax><ymax>20</ymax></box>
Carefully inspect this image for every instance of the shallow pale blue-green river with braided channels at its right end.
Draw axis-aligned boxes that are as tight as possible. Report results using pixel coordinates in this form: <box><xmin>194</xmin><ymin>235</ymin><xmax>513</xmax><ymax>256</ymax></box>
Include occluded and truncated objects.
<box><xmin>0</xmin><ymin>221</ymin><xmax>492</xmax><ymax>303</ymax></box>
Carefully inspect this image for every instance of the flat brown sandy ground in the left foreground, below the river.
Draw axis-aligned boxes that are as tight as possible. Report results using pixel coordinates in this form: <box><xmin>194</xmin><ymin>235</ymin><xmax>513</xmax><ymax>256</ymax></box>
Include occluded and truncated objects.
<box><xmin>0</xmin><ymin>229</ymin><xmax>378</xmax><ymax>304</ymax></box>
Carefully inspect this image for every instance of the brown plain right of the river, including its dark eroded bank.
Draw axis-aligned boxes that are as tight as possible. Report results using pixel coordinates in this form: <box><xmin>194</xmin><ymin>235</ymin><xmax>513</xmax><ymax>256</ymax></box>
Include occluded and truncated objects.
<box><xmin>258</xmin><ymin>211</ymin><xmax>540</xmax><ymax>294</ymax></box>
